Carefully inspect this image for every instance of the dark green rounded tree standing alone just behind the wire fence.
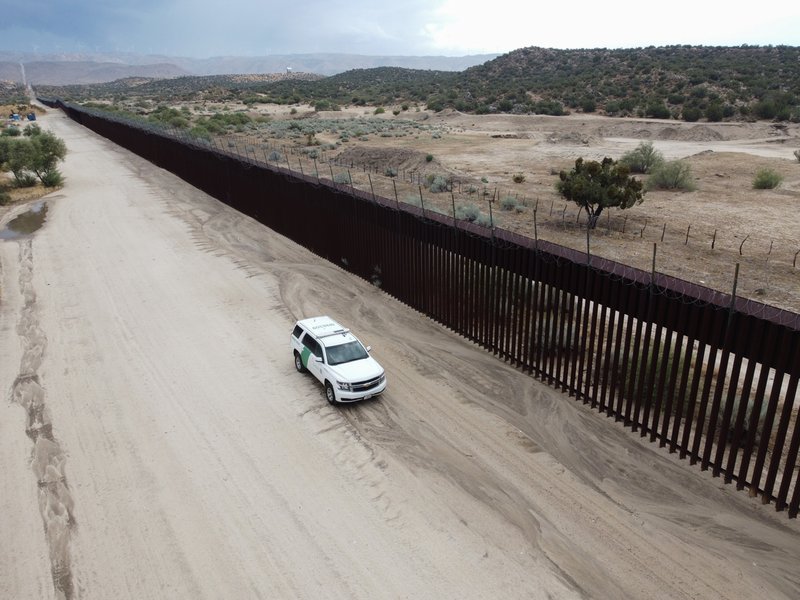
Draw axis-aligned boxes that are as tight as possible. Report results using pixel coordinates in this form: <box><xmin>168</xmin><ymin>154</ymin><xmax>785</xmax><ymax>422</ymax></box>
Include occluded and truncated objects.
<box><xmin>556</xmin><ymin>157</ymin><xmax>644</xmax><ymax>229</ymax></box>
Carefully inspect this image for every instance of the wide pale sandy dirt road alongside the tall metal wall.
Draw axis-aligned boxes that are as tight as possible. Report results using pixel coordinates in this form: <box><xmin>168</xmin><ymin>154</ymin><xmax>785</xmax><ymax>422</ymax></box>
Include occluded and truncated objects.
<box><xmin>0</xmin><ymin>113</ymin><xmax>800</xmax><ymax>599</ymax></box>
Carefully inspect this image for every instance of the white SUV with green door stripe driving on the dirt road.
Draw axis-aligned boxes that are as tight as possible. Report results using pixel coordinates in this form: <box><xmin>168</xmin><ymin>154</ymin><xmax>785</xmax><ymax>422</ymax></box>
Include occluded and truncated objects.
<box><xmin>290</xmin><ymin>317</ymin><xmax>386</xmax><ymax>404</ymax></box>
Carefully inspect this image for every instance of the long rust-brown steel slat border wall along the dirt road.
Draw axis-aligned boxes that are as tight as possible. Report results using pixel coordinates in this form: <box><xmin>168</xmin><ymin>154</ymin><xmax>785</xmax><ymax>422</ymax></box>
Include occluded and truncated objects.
<box><xmin>43</xmin><ymin>100</ymin><xmax>800</xmax><ymax>518</ymax></box>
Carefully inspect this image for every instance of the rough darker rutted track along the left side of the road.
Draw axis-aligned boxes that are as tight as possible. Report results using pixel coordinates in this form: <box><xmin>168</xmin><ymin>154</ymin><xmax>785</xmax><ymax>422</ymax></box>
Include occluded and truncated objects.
<box><xmin>11</xmin><ymin>238</ymin><xmax>76</xmax><ymax>600</ymax></box>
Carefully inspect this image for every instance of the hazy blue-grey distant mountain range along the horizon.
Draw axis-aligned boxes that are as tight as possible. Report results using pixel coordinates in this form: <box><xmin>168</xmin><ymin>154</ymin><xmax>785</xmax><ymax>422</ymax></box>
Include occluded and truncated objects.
<box><xmin>0</xmin><ymin>52</ymin><xmax>498</xmax><ymax>85</ymax></box>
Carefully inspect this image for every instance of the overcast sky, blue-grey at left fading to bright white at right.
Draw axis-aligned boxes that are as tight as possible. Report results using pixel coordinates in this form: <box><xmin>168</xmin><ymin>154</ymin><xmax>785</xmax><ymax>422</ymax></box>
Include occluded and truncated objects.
<box><xmin>0</xmin><ymin>0</ymin><xmax>800</xmax><ymax>58</ymax></box>
